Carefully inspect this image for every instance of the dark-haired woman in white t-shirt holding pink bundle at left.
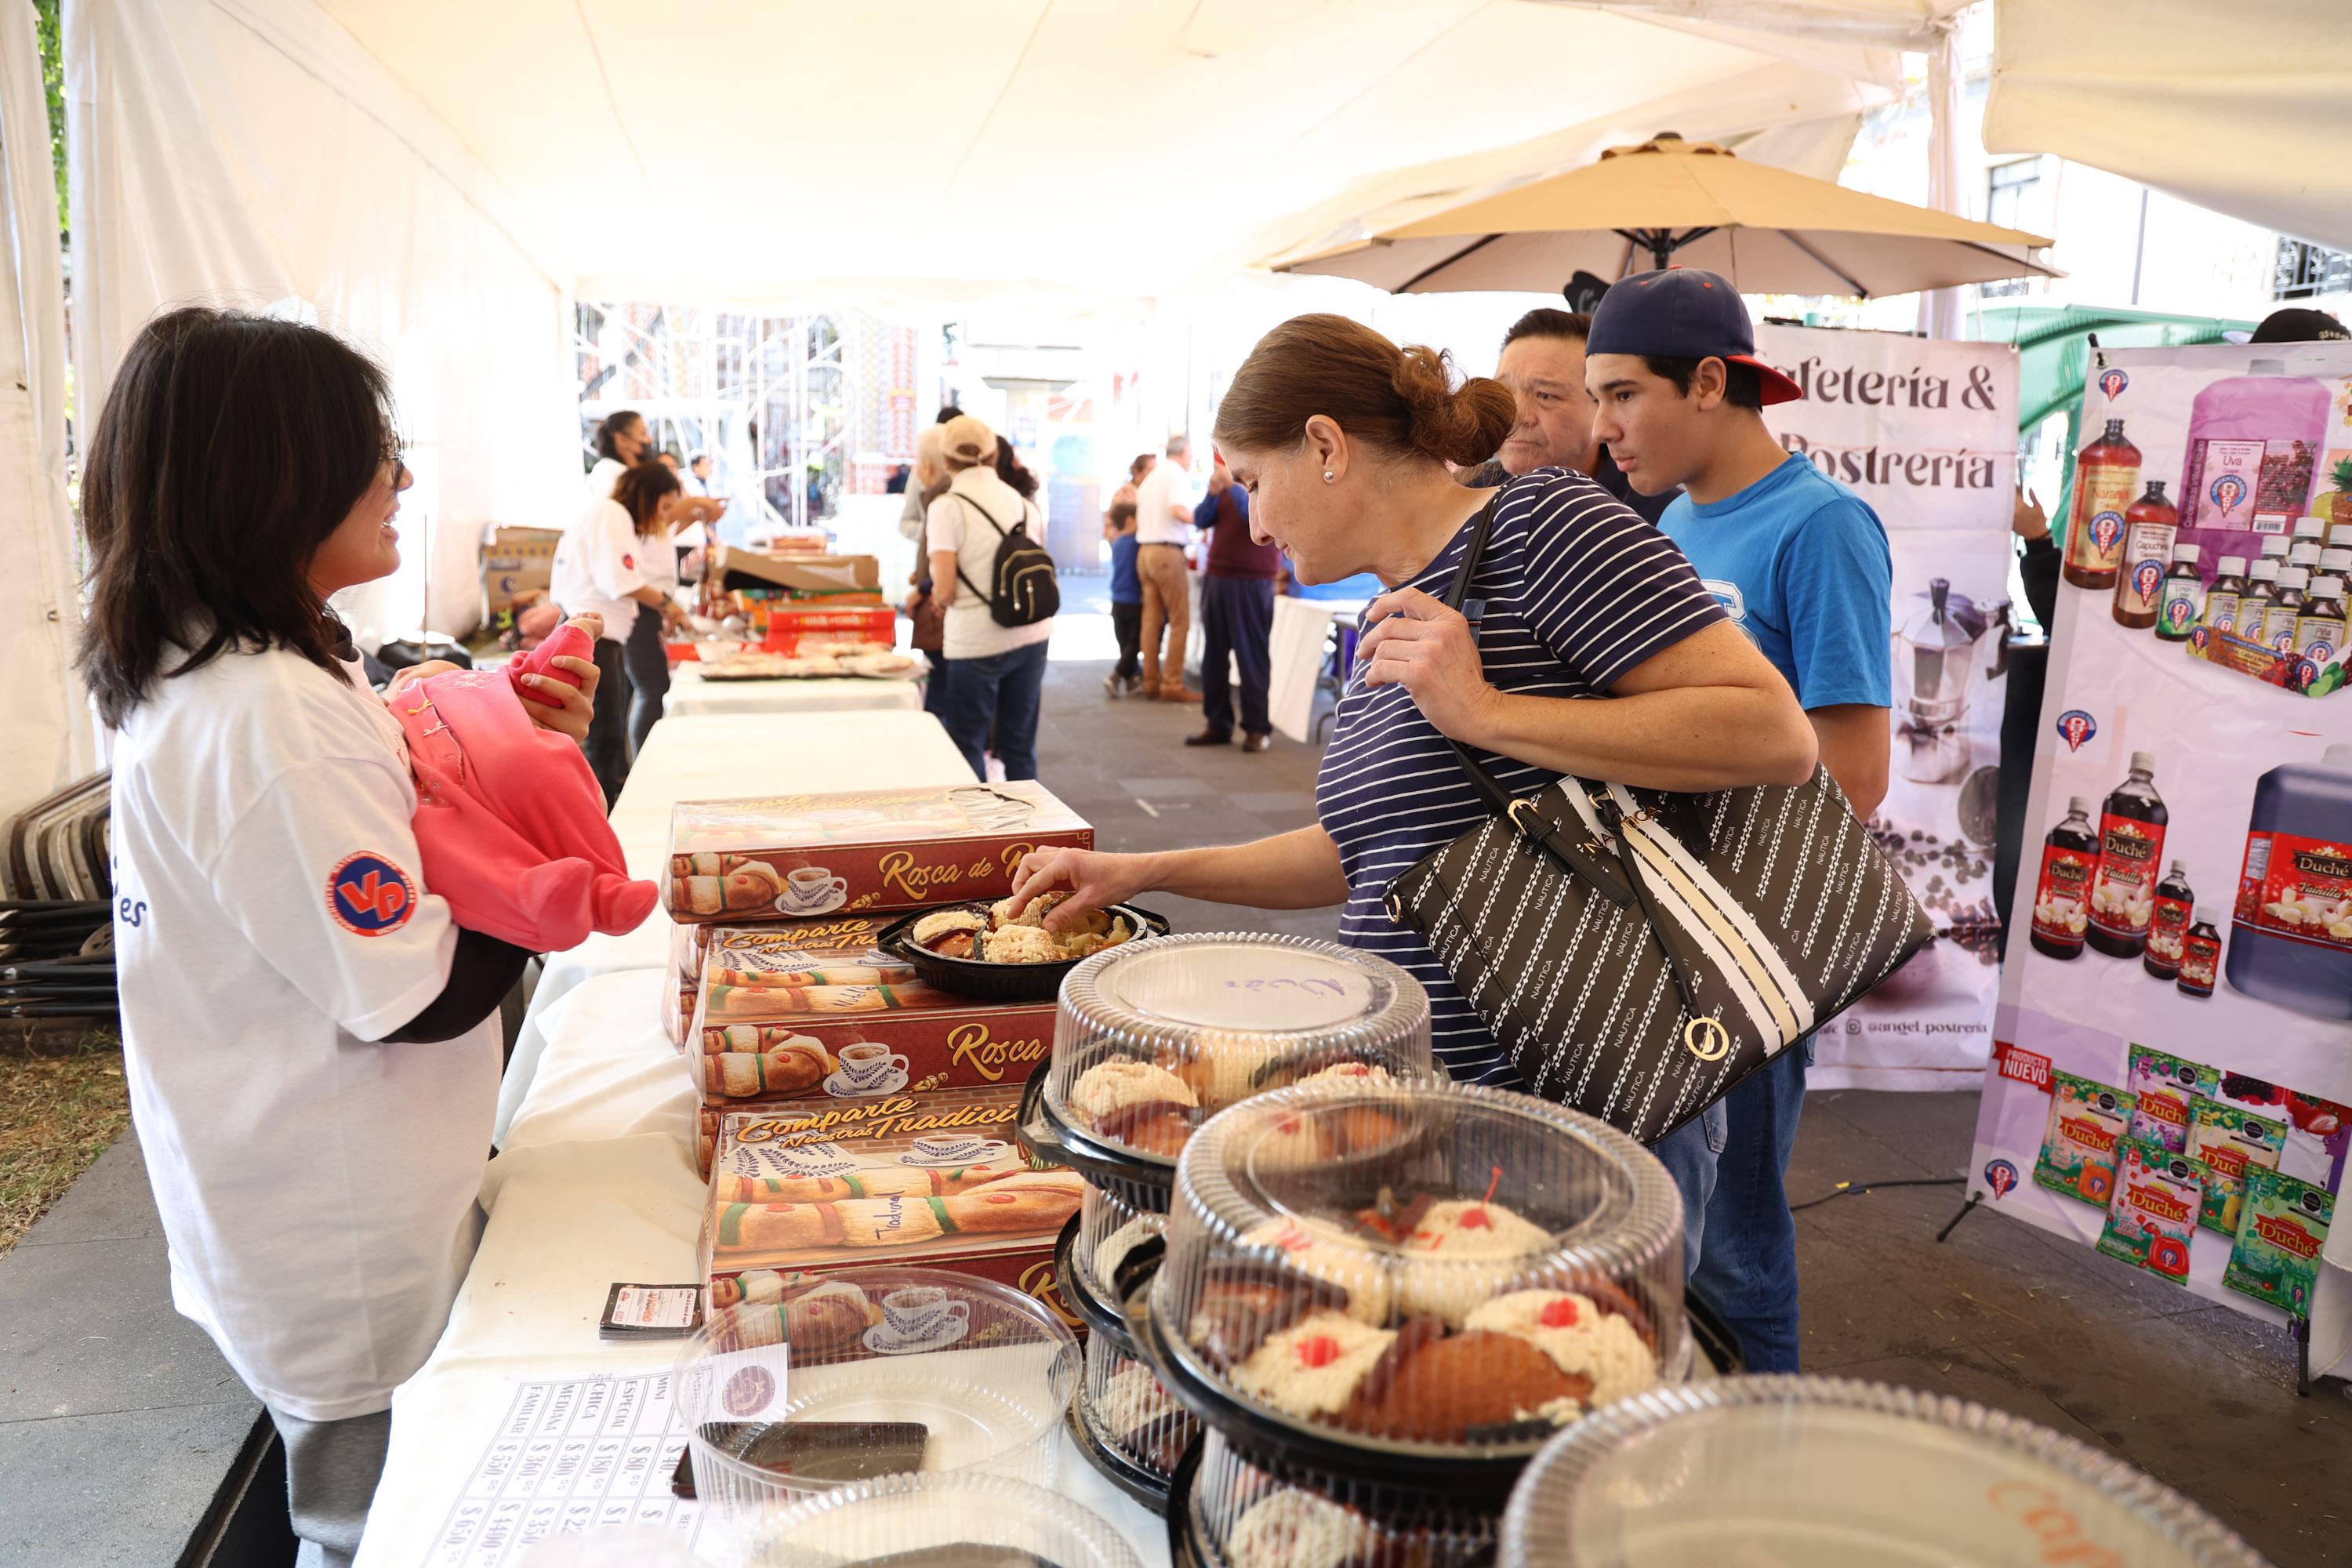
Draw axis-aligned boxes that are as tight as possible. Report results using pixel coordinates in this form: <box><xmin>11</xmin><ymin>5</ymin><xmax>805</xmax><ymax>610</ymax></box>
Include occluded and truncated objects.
<box><xmin>78</xmin><ymin>308</ymin><xmax>597</xmax><ymax>1563</ymax></box>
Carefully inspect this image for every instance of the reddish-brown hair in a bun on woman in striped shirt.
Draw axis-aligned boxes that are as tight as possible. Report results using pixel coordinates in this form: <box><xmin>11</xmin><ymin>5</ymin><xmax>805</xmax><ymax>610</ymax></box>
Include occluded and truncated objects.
<box><xmin>1216</xmin><ymin>315</ymin><xmax>1517</xmax><ymax>466</ymax></box>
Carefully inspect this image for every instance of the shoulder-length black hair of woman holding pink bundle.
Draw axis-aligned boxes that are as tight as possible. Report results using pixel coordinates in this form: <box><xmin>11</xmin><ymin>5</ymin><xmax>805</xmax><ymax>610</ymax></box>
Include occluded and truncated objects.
<box><xmin>75</xmin><ymin>308</ymin><xmax>393</xmax><ymax>727</ymax></box>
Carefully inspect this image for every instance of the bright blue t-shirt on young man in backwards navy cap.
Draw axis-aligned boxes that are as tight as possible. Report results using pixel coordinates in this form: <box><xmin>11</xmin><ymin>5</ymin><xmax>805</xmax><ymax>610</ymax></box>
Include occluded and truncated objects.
<box><xmin>1658</xmin><ymin>454</ymin><xmax>1896</xmax><ymax>708</ymax></box>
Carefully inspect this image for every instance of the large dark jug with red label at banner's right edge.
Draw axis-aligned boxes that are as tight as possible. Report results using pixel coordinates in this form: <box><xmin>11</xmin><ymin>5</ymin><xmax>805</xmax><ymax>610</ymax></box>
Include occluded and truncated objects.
<box><xmin>2230</xmin><ymin>746</ymin><xmax>2352</xmax><ymax>1018</ymax></box>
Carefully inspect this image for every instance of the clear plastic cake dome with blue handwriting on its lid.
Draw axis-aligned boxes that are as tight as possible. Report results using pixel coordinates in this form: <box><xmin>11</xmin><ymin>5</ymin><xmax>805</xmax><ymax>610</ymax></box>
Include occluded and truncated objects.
<box><xmin>1044</xmin><ymin>933</ymin><xmax>1435</xmax><ymax>1182</ymax></box>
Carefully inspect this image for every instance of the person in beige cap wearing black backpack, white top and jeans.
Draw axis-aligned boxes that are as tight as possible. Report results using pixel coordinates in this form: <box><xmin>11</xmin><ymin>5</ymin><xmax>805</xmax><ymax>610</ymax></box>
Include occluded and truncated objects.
<box><xmin>924</xmin><ymin>414</ymin><xmax>1058</xmax><ymax>779</ymax></box>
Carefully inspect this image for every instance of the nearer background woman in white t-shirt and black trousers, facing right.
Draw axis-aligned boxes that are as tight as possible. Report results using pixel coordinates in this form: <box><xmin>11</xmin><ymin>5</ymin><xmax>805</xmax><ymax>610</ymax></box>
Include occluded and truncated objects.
<box><xmin>548</xmin><ymin>463</ymin><xmax>708</xmax><ymax>806</ymax></box>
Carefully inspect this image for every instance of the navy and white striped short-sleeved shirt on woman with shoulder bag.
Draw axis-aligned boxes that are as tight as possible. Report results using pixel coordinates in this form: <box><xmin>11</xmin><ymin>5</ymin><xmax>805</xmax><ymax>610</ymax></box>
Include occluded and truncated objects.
<box><xmin>1315</xmin><ymin>468</ymin><xmax>1724</xmax><ymax>1088</ymax></box>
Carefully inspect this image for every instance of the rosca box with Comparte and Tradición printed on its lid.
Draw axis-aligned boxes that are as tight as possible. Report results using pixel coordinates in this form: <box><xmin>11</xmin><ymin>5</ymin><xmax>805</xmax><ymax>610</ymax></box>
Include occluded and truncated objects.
<box><xmin>701</xmin><ymin>1086</ymin><xmax>1087</xmax><ymax>1307</ymax></box>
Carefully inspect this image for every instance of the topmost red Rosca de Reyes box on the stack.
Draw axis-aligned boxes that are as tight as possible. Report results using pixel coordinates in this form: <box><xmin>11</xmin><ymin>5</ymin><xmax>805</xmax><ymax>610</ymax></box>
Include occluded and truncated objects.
<box><xmin>666</xmin><ymin>781</ymin><xmax>1094</xmax><ymax>921</ymax></box>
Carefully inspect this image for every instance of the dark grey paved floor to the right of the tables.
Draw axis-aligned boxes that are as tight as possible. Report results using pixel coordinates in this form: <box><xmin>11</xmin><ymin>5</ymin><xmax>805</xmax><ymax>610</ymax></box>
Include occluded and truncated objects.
<box><xmin>1037</xmin><ymin>630</ymin><xmax>2352</xmax><ymax>1568</ymax></box>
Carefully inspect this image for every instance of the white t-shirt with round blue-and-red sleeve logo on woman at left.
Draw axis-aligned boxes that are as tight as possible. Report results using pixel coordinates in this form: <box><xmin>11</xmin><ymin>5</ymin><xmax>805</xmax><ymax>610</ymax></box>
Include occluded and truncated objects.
<box><xmin>113</xmin><ymin>649</ymin><xmax>501</xmax><ymax>1420</ymax></box>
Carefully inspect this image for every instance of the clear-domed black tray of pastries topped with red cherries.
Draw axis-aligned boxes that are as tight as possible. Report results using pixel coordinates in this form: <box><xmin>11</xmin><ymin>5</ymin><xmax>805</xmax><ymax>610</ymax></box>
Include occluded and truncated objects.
<box><xmin>1141</xmin><ymin>1081</ymin><xmax>1691</xmax><ymax>1502</ymax></box>
